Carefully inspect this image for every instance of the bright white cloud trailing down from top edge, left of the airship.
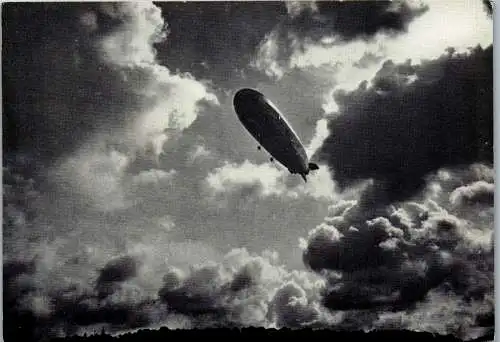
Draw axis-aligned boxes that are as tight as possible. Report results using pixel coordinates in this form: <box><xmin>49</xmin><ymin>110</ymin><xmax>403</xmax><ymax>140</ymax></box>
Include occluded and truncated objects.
<box><xmin>101</xmin><ymin>3</ymin><xmax>218</xmax><ymax>149</ymax></box>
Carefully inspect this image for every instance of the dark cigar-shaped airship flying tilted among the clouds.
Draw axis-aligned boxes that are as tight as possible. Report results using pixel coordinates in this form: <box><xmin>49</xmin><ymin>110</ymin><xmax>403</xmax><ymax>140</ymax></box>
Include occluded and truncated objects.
<box><xmin>233</xmin><ymin>88</ymin><xmax>319</xmax><ymax>182</ymax></box>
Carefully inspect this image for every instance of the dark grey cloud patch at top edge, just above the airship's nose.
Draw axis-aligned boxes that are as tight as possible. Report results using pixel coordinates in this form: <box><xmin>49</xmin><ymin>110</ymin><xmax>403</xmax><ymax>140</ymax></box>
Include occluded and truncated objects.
<box><xmin>154</xmin><ymin>1</ymin><xmax>286</xmax><ymax>83</ymax></box>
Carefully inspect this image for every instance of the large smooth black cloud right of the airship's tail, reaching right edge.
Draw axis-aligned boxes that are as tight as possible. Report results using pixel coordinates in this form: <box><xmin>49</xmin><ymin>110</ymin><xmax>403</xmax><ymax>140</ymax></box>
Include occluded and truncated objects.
<box><xmin>317</xmin><ymin>46</ymin><xmax>493</xmax><ymax>203</ymax></box>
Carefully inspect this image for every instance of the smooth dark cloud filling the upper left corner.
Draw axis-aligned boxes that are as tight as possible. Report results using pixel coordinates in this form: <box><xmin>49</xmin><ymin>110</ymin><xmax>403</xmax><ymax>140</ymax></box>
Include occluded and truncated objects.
<box><xmin>2</xmin><ymin>3</ymin><xmax>142</xmax><ymax>166</ymax></box>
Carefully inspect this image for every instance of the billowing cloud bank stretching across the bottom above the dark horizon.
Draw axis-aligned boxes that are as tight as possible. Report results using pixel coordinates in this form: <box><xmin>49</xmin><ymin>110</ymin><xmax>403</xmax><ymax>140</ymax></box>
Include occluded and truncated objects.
<box><xmin>3</xmin><ymin>164</ymin><xmax>494</xmax><ymax>336</ymax></box>
